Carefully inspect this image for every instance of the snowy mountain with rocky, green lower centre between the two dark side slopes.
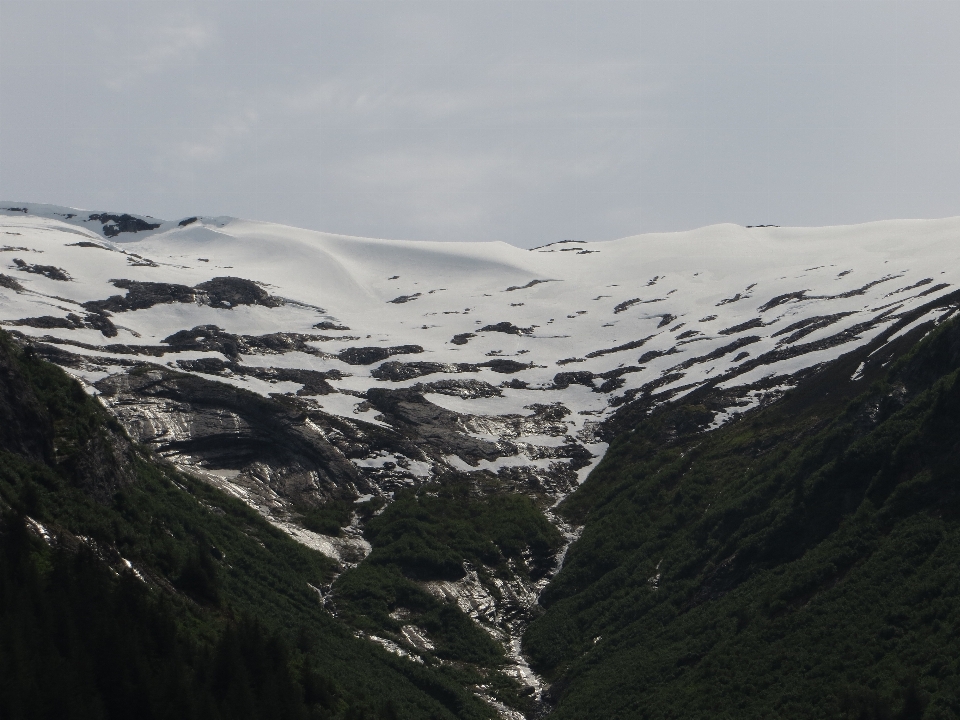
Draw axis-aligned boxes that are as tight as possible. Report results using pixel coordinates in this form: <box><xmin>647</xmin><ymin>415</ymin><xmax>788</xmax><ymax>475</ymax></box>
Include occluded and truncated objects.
<box><xmin>0</xmin><ymin>204</ymin><xmax>960</xmax><ymax>717</ymax></box>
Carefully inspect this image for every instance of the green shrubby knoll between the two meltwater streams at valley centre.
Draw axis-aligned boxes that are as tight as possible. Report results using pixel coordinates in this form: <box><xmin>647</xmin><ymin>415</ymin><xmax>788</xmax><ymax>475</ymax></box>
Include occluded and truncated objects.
<box><xmin>334</xmin><ymin>477</ymin><xmax>562</xmax><ymax>665</ymax></box>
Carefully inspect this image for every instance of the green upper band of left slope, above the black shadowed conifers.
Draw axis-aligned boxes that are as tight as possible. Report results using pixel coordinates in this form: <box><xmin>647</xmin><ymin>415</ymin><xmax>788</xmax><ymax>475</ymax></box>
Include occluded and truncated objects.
<box><xmin>0</xmin><ymin>337</ymin><xmax>490</xmax><ymax>718</ymax></box>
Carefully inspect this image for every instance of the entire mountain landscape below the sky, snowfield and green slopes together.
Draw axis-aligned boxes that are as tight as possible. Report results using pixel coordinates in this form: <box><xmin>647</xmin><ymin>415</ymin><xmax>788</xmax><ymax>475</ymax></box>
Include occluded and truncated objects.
<box><xmin>0</xmin><ymin>203</ymin><xmax>960</xmax><ymax>719</ymax></box>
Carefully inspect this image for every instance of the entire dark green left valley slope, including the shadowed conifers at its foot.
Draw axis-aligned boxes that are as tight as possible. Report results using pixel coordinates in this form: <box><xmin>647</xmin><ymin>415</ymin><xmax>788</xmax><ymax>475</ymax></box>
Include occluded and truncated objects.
<box><xmin>0</xmin><ymin>335</ymin><xmax>491</xmax><ymax>718</ymax></box>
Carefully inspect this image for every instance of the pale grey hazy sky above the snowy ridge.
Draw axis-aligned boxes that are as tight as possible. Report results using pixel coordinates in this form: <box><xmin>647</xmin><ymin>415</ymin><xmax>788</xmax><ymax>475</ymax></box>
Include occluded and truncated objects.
<box><xmin>0</xmin><ymin>0</ymin><xmax>960</xmax><ymax>247</ymax></box>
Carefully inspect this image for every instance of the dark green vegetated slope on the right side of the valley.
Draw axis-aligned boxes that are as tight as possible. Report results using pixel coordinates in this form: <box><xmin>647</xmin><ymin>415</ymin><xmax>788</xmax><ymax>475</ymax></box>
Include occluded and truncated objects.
<box><xmin>524</xmin><ymin>323</ymin><xmax>960</xmax><ymax>720</ymax></box>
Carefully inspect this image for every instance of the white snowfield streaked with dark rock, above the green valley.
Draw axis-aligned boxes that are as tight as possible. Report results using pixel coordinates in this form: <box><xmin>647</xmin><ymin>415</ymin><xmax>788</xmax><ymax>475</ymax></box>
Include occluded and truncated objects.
<box><xmin>0</xmin><ymin>203</ymin><xmax>960</xmax><ymax>512</ymax></box>
